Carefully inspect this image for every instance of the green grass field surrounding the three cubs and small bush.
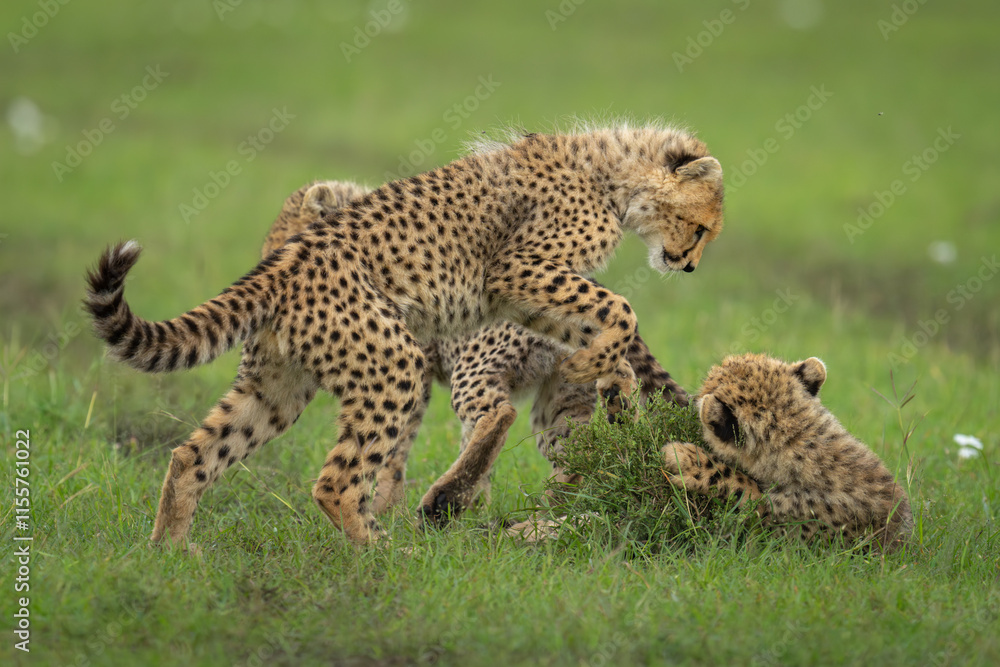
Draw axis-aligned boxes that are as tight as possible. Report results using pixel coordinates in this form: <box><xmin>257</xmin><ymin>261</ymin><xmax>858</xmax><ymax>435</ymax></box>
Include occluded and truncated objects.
<box><xmin>0</xmin><ymin>0</ymin><xmax>1000</xmax><ymax>665</ymax></box>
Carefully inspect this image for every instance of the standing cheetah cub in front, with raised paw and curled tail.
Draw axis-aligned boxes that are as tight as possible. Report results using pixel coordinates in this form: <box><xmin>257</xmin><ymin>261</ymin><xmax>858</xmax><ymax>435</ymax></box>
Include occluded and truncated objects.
<box><xmin>86</xmin><ymin>122</ymin><xmax>723</xmax><ymax>543</ymax></box>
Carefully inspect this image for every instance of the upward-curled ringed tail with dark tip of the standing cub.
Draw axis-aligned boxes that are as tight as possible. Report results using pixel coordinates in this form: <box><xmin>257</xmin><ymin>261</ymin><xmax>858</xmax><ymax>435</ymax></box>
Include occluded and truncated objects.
<box><xmin>83</xmin><ymin>241</ymin><xmax>281</xmax><ymax>373</ymax></box>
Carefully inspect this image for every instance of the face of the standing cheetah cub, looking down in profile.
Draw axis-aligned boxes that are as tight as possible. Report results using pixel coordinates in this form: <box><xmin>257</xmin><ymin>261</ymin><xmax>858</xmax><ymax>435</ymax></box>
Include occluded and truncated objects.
<box><xmin>622</xmin><ymin>156</ymin><xmax>723</xmax><ymax>273</ymax></box>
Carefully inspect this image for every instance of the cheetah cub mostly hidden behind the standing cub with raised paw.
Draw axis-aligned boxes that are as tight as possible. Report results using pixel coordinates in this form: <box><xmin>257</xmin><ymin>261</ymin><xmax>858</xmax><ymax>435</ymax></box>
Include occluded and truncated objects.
<box><xmin>257</xmin><ymin>181</ymin><xmax>688</xmax><ymax>524</ymax></box>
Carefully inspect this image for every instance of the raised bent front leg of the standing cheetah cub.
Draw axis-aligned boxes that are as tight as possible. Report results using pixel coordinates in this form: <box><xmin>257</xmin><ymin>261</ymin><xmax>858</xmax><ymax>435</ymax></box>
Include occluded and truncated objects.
<box><xmin>486</xmin><ymin>253</ymin><xmax>637</xmax><ymax>408</ymax></box>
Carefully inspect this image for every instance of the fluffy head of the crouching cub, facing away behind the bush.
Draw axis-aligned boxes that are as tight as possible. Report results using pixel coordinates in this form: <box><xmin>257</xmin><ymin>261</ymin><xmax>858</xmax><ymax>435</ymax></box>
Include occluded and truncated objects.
<box><xmin>695</xmin><ymin>354</ymin><xmax>826</xmax><ymax>461</ymax></box>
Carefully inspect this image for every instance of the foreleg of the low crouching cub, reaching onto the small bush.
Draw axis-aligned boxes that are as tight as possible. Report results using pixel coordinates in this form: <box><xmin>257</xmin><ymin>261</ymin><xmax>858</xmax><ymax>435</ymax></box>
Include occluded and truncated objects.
<box><xmin>661</xmin><ymin>442</ymin><xmax>761</xmax><ymax>505</ymax></box>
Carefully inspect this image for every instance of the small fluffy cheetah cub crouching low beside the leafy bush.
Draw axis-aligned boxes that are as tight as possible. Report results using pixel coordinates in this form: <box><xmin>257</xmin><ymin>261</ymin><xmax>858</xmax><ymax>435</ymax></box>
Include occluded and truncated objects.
<box><xmin>663</xmin><ymin>354</ymin><xmax>913</xmax><ymax>549</ymax></box>
